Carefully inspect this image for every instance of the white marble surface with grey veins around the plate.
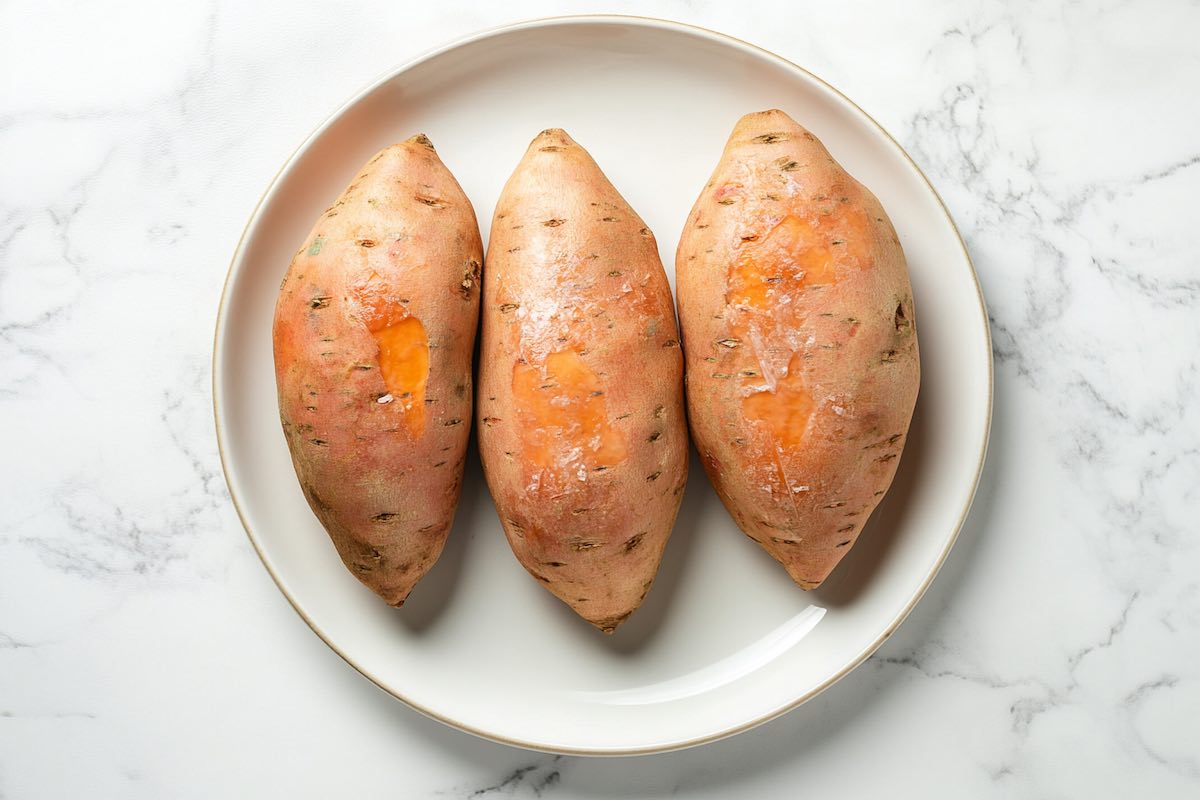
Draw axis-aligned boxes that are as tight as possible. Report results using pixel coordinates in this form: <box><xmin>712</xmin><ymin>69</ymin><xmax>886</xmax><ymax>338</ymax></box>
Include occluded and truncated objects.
<box><xmin>0</xmin><ymin>0</ymin><xmax>1200</xmax><ymax>798</ymax></box>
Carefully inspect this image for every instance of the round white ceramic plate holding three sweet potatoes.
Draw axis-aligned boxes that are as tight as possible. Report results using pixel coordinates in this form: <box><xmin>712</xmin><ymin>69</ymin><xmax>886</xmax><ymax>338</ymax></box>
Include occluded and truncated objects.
<box><xmin>214</xmin><ymin>17</ymin><xmax>991</xmax><ymax>754</ymax></box>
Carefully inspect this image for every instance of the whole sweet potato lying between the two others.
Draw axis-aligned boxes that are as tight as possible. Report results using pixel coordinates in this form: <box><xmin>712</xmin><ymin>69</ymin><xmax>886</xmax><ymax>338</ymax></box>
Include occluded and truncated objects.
<box><xmin>478</xmin><ymin>130</ymin><xmax>688</xmax><ymax>632</ymax></box>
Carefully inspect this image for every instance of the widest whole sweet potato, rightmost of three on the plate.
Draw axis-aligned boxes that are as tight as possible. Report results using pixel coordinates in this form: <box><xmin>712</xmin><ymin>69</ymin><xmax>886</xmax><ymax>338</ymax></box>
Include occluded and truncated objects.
<box><xmin>676</xmin><ymin>110</ymin><xmax>920</xmax><ymax>589</ymax></box>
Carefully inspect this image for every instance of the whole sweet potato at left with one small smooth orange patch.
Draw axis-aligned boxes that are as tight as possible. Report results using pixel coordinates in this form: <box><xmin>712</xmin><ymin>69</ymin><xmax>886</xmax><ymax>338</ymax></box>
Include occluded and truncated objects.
<box><xmin>274</xmin><ymin>136</ymin><xmax>482</xmax><ymax>606</ymax></box>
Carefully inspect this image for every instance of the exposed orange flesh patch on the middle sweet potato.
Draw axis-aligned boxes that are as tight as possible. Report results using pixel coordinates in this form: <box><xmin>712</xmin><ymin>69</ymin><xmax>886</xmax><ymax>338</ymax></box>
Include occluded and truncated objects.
<box><xmin>512</xmin><ymin>350</ymin><xmax>626</xmax><ymax>487</ymax></box>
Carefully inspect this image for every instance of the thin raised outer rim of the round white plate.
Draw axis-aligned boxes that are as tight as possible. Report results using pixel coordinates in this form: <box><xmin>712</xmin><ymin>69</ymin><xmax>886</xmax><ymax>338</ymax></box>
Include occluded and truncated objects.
<box><xmin>211</xmin><ymin>13</ymin><xmax>995</xmax><ymax>757</ymax></box>
